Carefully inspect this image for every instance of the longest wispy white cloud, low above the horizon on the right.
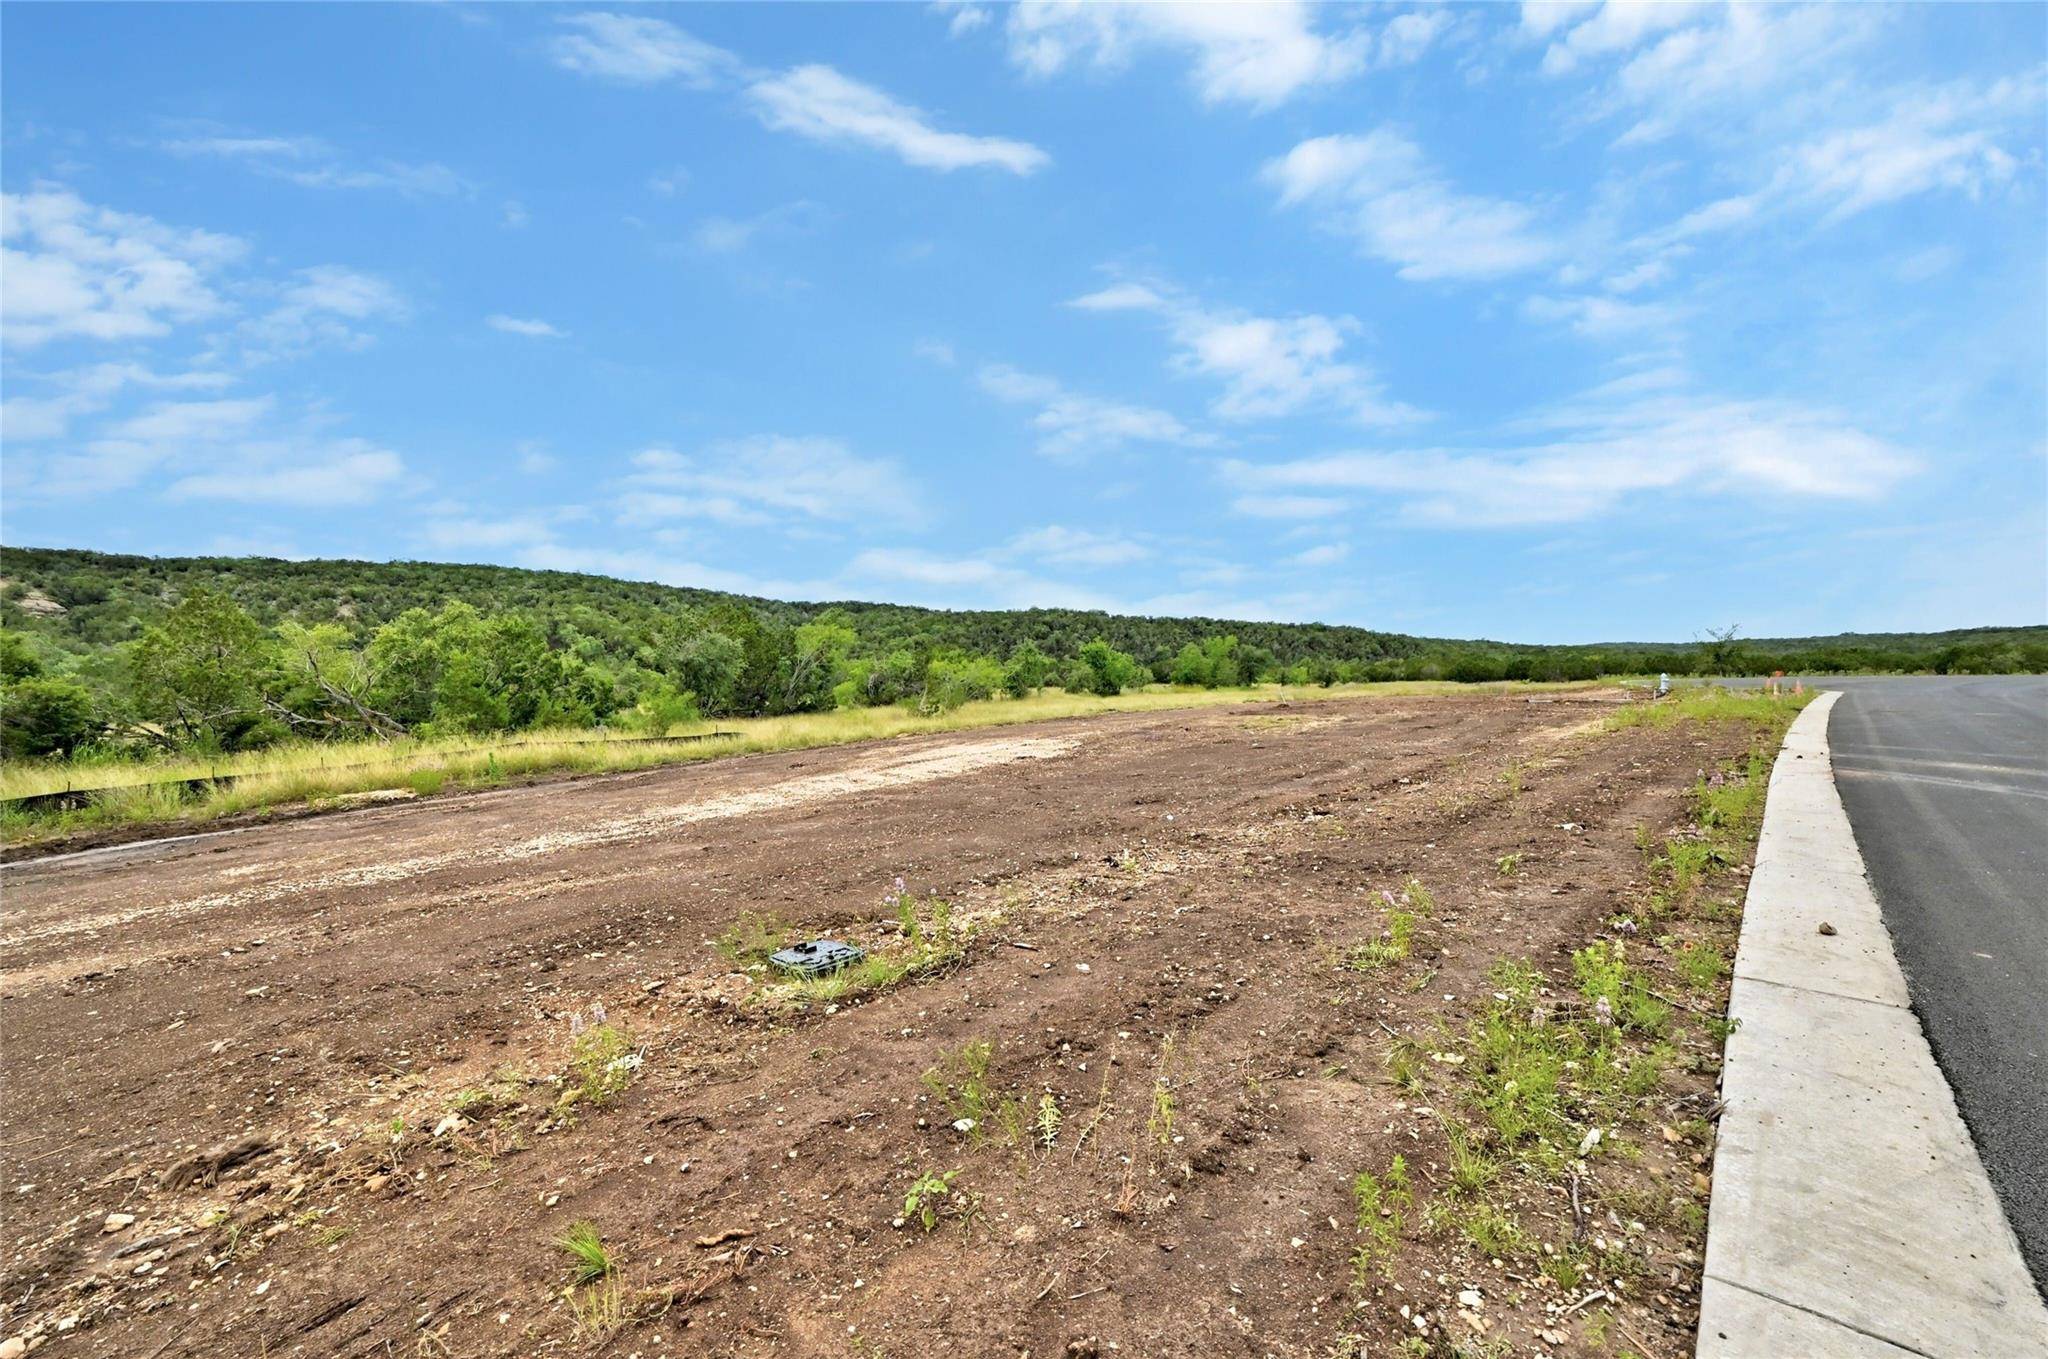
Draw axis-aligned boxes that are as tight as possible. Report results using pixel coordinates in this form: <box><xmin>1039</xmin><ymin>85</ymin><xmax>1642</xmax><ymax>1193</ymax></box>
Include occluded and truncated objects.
<box><xmin>1221</xmin><ymin>395</ymin><xmax>1919</xmax><ymax>528</ymax></box>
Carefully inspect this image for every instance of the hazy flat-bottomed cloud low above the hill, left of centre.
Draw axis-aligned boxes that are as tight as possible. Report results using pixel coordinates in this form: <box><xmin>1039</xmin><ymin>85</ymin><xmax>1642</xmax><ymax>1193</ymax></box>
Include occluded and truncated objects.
<box><xmin>627</xmin><ymin>434</ymin><xmax>924</xmax><ymax>524</ymax></box>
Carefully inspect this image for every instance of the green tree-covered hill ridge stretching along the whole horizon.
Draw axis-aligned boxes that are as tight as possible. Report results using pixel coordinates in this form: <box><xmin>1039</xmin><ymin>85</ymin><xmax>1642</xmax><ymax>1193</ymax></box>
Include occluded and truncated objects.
<box><xmin>0</xmin><ymin>549</ymin><xmax>2048</xmax><ymax>757</ymax></box>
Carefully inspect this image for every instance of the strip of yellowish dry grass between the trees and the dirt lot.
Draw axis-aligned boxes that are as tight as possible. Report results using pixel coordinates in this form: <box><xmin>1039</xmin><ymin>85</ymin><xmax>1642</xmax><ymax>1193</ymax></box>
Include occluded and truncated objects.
<box><xmin>0</xmin><ymin>682</ymin><xmax>1585</xmax><ymax>845</ymax></box>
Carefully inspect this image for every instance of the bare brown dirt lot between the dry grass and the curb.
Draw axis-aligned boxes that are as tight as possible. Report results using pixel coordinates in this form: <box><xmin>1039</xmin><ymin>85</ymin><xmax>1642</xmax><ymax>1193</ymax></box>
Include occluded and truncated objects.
<box><xmin>0</xmin><ymin>694</ymin><xmax>1749</xmax><ymax>1359</ymax></box>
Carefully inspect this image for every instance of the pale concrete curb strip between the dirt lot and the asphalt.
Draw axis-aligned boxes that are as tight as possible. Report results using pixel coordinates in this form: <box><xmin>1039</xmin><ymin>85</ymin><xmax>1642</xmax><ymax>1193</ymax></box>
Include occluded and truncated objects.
<box><xmin>1698</xmin><ymin>692</ymin><xmax>2048</xmax><ymax>1359</ymax></box>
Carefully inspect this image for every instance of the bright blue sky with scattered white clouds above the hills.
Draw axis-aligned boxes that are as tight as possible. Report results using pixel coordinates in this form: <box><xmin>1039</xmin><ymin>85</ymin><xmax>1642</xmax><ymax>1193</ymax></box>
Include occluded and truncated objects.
<box><xmin>0</xmin><ymin>4</ymin><xmax>2048</xmax><ymax>641</ymax></box>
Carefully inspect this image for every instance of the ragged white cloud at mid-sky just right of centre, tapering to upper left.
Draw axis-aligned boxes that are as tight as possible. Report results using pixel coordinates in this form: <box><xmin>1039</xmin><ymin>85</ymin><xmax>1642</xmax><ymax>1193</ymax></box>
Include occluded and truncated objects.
<box><xmin>1071</xmin><ymin>282</ymin><xmax>1421</xmax><ymax>426</ymax></box>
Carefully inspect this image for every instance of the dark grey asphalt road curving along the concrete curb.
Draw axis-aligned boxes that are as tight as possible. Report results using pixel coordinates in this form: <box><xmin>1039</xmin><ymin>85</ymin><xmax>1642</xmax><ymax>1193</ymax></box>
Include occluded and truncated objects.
<box><xmin>1744</xmin><ymin>675</ymin><xmax>2048</xmax><ymax>1294</ymax></box>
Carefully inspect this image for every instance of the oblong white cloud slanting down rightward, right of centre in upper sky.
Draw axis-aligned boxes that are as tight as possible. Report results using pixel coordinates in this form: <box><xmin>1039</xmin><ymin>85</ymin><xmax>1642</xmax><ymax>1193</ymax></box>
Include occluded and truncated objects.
<box><xmin>1262</xmin><ymin>129</ymin><xmax>1556</xmax><ymax>280</ymax></box>
